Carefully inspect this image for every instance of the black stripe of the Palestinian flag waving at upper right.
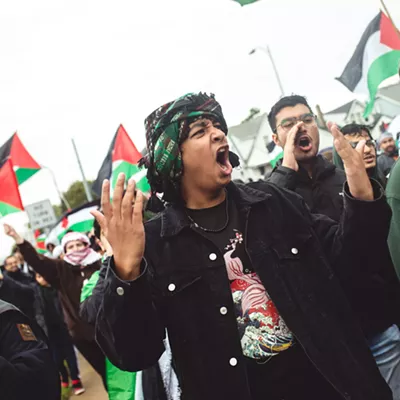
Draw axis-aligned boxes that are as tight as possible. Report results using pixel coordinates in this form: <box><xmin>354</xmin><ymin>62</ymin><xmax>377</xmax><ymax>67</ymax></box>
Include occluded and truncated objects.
<box><xmin>336</xmin><ymin>13</ymin><xmax>381</xmax><ymax>92</ymax></box>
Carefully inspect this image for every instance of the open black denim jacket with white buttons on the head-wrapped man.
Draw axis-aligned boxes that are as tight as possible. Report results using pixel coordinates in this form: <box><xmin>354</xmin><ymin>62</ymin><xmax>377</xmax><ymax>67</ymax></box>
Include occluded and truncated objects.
<box><xmin>96</xmin><ymin>182</ymin><xmax>392</xmax><ymax>400</ymax></box>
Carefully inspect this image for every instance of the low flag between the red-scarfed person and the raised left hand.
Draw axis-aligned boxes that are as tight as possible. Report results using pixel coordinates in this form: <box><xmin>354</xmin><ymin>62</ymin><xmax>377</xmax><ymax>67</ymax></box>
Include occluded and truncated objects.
<box><xmin>47</xmin><ymin>200</ymin><xmax>100</xmax><ymax>240</ymax></box>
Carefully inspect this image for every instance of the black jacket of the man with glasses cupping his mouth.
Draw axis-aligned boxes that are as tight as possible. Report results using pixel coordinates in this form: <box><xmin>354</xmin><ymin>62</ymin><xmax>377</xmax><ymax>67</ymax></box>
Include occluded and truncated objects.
<box><xmin>268</xmin><ymin>156</ymin><xmax>400</xmax><ymax>338</ymax></box>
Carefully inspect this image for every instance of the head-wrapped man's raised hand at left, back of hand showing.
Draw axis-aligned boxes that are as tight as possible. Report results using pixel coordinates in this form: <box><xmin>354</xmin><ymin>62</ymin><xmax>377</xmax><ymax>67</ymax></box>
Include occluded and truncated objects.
<box><xmin>92</xmin><ymin>174</ymin><xmax>145</xmax><ymax>280</ymax></box>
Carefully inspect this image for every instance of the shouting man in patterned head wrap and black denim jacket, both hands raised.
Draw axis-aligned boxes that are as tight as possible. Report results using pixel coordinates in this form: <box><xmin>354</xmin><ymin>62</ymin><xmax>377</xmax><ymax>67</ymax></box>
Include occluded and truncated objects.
<box><xmin>94</xmin><ymin>93</ymin><xmax>392</xmax><ymax>400</ymax></box>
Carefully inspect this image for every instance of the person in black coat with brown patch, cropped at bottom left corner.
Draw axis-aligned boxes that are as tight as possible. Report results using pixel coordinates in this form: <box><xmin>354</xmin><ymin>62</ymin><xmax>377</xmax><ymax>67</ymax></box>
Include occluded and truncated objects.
<box><xmin>0</xmin><ymin>300</ymin><xmax>60</xmax><ymax>400</ymax></box>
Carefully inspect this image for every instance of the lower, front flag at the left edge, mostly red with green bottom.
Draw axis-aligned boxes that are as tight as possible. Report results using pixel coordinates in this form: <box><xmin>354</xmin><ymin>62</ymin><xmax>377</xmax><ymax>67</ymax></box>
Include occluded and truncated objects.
<box><xmin>0</xmin><ymin>159</ymin><xmax>24</xmax><ymax>218</ymax></box>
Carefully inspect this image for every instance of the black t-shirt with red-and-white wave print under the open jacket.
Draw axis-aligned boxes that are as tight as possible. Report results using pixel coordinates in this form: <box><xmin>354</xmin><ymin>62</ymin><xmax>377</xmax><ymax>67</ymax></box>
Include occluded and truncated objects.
<box><xmin>186</xmin><ymin>198</ymin><xmax>293</xmax><ymax>360</ymax></box>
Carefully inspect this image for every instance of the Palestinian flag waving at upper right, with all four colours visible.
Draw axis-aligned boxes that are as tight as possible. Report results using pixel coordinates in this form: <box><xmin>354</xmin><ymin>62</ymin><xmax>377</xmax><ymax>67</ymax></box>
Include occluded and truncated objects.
<box><xmin>337</xmin><ymin>12</ymin><xmax>400</xmax><ymax>118</ymax></box>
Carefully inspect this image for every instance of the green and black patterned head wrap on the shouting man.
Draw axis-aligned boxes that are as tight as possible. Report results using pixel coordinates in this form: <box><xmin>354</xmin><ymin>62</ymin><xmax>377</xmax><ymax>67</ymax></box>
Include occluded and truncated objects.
<box><xmin>141</xmin><ymin>93</ymin><xmax>228</xmax><ymax>201</ymax></box>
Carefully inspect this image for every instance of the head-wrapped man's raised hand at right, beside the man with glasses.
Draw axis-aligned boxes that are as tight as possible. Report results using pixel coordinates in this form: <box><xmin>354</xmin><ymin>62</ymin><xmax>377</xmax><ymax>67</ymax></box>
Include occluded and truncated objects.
<box><xmin>328</xmin><ymin>122</ymin><xmax>374</xmax><ymax>201</ymax></box>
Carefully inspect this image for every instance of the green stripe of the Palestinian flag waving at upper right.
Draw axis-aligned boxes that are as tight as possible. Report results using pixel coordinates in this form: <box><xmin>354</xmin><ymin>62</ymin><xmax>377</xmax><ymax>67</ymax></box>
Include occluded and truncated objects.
<box><xmin>364</xmin><ymin>50</ymin><xmax>400</xmax><ymax>118</ymax></box>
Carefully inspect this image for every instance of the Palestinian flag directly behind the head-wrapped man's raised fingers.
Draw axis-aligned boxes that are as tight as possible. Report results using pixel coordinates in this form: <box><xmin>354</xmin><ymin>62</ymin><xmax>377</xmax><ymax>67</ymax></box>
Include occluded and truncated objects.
<box><xmin>92</xmin><ymin>125</ymin><xmax>150</xmax><ymax>196</ymax></box>
